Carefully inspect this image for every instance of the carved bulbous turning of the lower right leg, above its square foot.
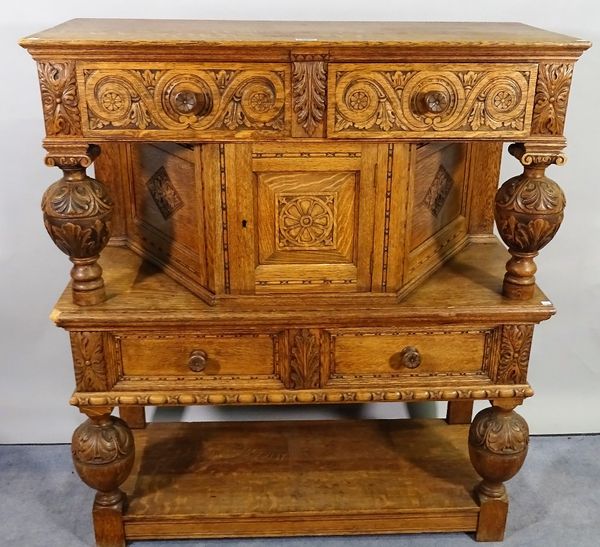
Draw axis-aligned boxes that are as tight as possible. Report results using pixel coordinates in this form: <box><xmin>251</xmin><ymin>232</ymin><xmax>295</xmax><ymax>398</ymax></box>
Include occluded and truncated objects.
<box><xmin>469</xmin><ymin>406</ymin><xmax>529</xmax><ymax>498</ymax></box>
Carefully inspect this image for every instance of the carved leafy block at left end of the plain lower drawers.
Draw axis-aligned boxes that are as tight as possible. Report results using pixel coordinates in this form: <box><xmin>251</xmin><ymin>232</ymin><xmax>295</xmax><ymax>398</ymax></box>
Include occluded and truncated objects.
<box><xmin>71</xmin><ymin>332</ymin><xmax>108</xmax><ymax>391</ymax></box>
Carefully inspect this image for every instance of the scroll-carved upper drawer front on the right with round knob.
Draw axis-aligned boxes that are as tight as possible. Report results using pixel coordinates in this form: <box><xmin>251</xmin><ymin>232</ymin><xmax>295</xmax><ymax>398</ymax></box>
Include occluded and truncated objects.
<box><xmin>327</xmin><ymin>63</ymin><xmax>537</xmax><ymax>139</ymax></box>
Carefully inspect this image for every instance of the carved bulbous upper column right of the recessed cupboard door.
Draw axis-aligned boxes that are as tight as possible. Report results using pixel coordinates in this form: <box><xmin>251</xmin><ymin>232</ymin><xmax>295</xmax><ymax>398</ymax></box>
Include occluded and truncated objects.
<box><xmin>495</xmin><ymin>144</ymin><xmax>565</xmax><ymax>300</ymax></box>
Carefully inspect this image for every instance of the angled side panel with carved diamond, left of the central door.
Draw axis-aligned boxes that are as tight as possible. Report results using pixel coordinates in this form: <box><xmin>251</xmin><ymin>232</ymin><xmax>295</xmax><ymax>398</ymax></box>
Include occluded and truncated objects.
<box><xmin>129</xmin><ymin>143</ymin><xmax>208</xmax><ymax>294</ymax></box>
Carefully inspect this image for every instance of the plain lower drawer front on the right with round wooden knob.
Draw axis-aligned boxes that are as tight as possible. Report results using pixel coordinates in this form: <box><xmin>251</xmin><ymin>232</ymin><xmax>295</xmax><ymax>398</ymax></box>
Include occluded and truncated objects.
<box><xmin>329</xmin><ymin>329</ymin><xmax>494</xmax><ymax>384</ymax></box>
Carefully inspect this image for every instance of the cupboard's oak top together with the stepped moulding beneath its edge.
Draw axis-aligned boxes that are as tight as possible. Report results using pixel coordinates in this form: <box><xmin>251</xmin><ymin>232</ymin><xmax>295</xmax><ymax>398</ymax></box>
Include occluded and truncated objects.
<box><xmin>21</xmin><ymin>19</ymin><xmax>590</xmax><ymax>62</ymax></box>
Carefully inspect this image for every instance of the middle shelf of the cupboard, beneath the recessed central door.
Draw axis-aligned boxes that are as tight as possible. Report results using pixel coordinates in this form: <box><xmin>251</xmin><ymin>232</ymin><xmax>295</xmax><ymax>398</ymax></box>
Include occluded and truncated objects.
<box><xmin>51</xmin><ymin>240</ymin><xmax>555</xmax><ymax>330</ymax></box>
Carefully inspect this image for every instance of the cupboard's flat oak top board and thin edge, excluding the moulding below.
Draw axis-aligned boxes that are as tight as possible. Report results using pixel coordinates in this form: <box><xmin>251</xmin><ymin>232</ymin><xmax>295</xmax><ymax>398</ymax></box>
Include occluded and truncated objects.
<box><xmin>21</xmin><ymin>19</ymin><xmax>590</xmax><ymax>57</ymax></box>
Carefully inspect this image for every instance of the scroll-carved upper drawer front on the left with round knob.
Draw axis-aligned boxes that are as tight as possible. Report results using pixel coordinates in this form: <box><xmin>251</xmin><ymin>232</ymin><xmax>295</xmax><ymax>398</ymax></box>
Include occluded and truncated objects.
<box><xmin>77</xmin><ymin>63</ymin><xmax>291</xmax><ymax>140</ymax></box>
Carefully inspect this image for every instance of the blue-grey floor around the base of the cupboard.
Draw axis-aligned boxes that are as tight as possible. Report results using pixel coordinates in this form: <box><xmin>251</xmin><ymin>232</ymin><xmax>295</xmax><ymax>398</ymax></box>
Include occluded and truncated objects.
<box><xmin>0</xmin><ymin>436</ymin><xmax>600</xmax><ymax>547</ymax></box>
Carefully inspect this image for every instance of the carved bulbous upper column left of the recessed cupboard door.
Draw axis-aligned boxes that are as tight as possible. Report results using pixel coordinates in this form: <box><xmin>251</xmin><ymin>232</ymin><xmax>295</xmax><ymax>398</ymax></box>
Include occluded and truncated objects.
<box><xmin>42</xmin><ymin>146</ymin><xmax>113</xmax><ymax>306</ymax></box>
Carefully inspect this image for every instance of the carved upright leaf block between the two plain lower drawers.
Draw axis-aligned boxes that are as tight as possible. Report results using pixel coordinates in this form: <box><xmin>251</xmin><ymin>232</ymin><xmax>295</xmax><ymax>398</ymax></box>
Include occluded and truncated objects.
<box><xmin>287</xmin><ymin>329</ymin><xmax>320</xmax><ymax>389</ymax></box>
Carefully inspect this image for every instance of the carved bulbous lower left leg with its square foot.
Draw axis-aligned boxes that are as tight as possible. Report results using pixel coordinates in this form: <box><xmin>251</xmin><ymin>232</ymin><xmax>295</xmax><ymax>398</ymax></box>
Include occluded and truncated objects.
<box><xmin>71</xmin><ymin>409</ymin><xmax>135</xmax><ymax>547</ymax></box>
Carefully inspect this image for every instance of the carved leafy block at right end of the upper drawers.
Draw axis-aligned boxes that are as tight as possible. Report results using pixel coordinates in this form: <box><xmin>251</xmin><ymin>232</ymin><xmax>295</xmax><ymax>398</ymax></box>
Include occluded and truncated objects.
<box><xmin>531</xmin><ymin>64</ymin><xmax>573</xmax><ymax>135</ymax></box>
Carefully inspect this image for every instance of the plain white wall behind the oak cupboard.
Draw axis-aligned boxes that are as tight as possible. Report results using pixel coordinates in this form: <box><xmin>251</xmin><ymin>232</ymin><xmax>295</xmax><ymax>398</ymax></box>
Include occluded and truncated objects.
<box><xmin>0</xmin><ymin>0</ymin><xmax>600</xmax><ymax>443</ymax></box>
